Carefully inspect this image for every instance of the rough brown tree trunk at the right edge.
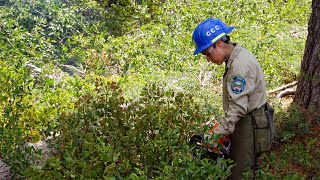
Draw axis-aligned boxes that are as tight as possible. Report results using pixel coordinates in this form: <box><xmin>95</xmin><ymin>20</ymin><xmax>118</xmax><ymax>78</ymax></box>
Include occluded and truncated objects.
<box><xmin>294</xmin><ymin>0</ymin><xmax>320</xmax><ymax>113</ymax></box>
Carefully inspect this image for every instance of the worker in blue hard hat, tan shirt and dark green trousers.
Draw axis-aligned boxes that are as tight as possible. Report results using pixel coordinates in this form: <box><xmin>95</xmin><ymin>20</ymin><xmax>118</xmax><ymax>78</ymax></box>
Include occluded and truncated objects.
<box><xmin>192</xmin><ymin>18</ymin><xmax>273</xmax><ymax>179</ymax></box>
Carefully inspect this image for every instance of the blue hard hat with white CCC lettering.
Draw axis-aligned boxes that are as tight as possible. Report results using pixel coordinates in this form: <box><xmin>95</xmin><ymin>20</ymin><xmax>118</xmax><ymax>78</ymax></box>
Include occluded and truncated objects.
<box><xmin>192</xmin><ymin>18</ymin><xmax>236</xmax><ymax>55</ymax></box>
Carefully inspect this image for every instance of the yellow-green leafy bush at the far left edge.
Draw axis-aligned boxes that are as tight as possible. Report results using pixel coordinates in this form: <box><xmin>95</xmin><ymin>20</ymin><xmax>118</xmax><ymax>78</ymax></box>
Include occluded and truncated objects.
<box><xmin>0</xmin><ymin>61</ymin><xmax>33</xmax><ymax>175</ymax></box>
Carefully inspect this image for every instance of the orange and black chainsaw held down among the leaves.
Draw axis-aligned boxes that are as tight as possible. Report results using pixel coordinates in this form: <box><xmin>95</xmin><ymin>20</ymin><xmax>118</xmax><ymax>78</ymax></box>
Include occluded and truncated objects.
<box><xmin>189</xmin><ymin>123</ymin><xmax>231</xmax><ymax>160</ymax></box>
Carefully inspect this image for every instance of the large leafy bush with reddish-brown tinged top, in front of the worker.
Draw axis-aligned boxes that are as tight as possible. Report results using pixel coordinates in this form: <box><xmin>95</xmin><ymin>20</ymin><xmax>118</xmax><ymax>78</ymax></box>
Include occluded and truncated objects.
<box><xmin>25</xmin><ymin>81</ymin><xmax>231</xmax><ymax>179</ymax></box>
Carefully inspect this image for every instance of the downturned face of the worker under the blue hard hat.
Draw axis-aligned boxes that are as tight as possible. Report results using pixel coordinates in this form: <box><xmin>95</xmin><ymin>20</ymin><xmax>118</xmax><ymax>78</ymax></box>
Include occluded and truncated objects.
<box><xmin>202</xmin><ymin>41</ymin><xmax>225</xmax><ymax>65</ymax></box>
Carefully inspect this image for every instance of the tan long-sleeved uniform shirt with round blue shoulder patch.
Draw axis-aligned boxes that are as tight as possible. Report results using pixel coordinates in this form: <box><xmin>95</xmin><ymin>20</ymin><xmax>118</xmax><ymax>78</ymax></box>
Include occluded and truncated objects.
<box><xmin>214</xmin><ymin>44</ymin><xmax>266</xmax><ymax>135</ymax></box>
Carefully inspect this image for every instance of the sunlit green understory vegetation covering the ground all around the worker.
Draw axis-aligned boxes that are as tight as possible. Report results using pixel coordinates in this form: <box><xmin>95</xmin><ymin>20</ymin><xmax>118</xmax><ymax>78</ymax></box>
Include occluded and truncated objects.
<box><xmin>0</xmin><ymin>0</ymin><xmax>320</xmax><ymax>179</ymax></box>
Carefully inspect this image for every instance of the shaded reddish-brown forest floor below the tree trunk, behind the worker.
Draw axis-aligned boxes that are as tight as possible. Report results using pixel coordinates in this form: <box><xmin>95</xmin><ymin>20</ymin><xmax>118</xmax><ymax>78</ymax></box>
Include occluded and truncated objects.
<box><xmin>264</xmin><ymin>96</ymin><xmax>320</xmax><ymax>180</ymax></box>
